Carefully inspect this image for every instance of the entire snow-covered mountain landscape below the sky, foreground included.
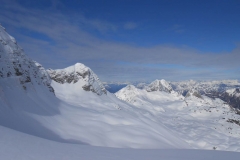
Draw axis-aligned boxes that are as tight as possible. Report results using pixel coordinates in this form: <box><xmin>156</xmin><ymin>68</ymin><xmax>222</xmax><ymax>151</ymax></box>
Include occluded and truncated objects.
<box><xmin>0</xmin><ymin>25</ymin><xmax>240</xmax><ymax>160</ymax></box>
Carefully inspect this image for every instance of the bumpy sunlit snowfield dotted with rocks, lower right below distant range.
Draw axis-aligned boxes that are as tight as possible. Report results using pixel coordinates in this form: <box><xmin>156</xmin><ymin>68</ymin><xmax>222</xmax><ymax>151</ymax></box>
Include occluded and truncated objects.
<box><xmin>116</xmin><ymin>81</ymin><xmax>240</xmax><ymax>151</ymax></box>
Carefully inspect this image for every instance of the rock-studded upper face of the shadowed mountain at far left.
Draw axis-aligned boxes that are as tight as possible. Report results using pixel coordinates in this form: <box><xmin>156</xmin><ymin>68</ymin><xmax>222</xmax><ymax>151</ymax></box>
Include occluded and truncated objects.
<box><xmin>0</xmin><ymin>25</ymin><xmax>54</xmax><ymax>92</ymax></box>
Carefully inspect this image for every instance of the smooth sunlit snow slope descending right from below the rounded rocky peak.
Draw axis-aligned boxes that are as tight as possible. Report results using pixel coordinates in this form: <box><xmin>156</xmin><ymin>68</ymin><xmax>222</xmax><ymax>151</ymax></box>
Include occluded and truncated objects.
<box><xmin>49</xmin><ymin>63</ymin><xmax>190</xmax><ymax>148</ymax></box>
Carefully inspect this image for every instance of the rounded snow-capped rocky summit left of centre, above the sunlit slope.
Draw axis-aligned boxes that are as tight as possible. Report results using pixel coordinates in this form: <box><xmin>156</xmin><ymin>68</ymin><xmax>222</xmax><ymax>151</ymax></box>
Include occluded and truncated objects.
<box><xmin>47</xmin><ymin>63</ymin><xmax>107</xmax><ymax>95</ymax></box>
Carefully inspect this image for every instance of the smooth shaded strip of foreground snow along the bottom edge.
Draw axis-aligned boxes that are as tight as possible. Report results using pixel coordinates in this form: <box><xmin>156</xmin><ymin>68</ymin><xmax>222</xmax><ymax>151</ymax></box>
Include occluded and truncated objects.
<box><xmin>0</xmin><ymin>126</ymin><xmax>240</xmax><ymax>160</ymax></box>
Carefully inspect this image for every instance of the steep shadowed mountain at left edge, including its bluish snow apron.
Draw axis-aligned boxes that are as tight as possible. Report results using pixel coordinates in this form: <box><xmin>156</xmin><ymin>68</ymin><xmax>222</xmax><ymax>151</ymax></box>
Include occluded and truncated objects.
<box><xmin>0</xmin><ymin>26</ymin><xmax>60</xmax><ymax>140</ymax></box>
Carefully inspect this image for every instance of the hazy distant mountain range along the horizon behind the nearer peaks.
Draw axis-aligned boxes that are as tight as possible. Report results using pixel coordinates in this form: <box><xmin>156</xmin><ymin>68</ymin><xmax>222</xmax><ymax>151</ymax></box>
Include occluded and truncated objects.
<box><xmin>104</xmin><ymin>80</ymin><xmax>240</xmax><ymax>109</ymax></box>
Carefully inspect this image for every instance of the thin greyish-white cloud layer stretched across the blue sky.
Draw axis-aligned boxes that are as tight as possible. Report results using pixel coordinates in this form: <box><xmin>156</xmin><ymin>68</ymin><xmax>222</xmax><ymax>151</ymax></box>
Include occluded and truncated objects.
<box><xmin>0</xmin><ymin>0</ymin><xmax>240</xmax><ymax>80</ymax></box>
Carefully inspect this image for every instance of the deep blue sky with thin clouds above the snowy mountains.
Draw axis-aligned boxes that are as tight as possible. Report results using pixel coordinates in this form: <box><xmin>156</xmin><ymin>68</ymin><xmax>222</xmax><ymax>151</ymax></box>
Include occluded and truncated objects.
<box><xmin>0</xmin><ymin>0</ymin><xmax>240</xmax><ymax>82</ymax></box>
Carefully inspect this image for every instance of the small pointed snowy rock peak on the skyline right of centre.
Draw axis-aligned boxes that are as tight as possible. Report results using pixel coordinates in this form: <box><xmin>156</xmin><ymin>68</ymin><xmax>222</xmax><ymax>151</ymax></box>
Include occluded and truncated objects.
<box><xmin>146</xmin><ymin>79</ymin><xmax>173</xmax><ymax>93</ymax></box>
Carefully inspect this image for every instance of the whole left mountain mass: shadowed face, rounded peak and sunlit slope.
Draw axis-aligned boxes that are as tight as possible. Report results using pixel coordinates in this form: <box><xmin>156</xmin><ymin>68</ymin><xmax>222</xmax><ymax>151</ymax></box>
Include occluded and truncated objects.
<box><xmin>0</xmin><ymin>24</ymin><xmax>191</xmax><ymax>149</ymax></box>
